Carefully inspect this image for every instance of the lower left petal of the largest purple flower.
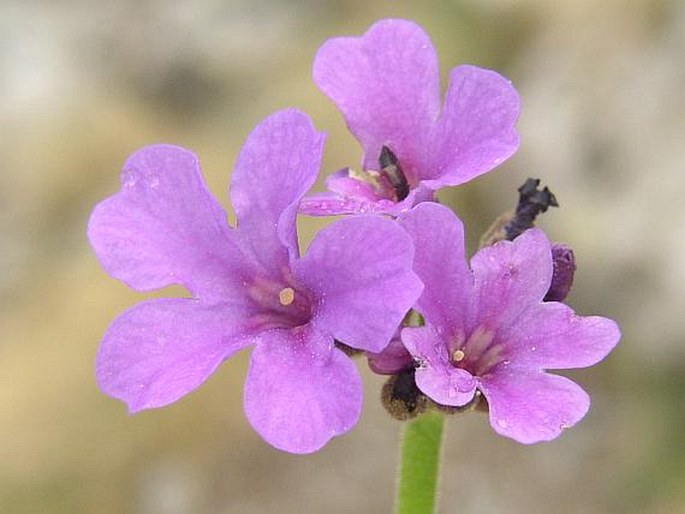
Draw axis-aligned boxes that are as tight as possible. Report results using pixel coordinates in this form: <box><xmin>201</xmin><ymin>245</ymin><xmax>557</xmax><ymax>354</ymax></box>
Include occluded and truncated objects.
<box><xmin>96</xmin><ymin>298</ymin><xmax>251</xmax><ymax>413</ymax></box>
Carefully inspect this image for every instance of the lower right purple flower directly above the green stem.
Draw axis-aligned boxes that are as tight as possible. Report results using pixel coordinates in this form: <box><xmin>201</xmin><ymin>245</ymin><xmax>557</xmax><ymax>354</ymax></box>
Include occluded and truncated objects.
<box><xmin>400</xmin><ymin>203</ymin><xmax>620</xmax><ymax>444</ymax></box>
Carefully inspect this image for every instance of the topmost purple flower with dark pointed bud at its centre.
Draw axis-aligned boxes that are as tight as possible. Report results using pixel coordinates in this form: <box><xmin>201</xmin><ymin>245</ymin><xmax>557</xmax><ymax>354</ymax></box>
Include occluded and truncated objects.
<box><xmin>300</xmin><ymin>19</ymin><xmax>519</xmax><ymax>215</ymax></box>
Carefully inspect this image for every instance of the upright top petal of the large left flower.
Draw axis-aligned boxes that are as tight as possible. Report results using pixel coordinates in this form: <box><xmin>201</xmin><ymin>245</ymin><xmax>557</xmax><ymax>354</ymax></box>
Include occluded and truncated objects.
<box><xmin>231</xmin><ymin>109</ymin><xmax>324</xmax><ymax>269</ymax></box>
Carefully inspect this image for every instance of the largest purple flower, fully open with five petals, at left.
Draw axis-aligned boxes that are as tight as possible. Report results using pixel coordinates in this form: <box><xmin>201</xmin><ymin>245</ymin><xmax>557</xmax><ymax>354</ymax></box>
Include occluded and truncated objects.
<box><xmin>88</xmin><ymin>110</ymin><xmax>422</xmax><ymax>453</ymax></box>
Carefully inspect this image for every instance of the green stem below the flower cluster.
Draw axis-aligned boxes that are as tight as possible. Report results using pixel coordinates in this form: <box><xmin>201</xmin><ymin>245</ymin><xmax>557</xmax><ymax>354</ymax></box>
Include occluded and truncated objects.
<box><xmin>395</xmin><ymin>412</ymin><xmax>445</xmax><ymax>514</ymax></box>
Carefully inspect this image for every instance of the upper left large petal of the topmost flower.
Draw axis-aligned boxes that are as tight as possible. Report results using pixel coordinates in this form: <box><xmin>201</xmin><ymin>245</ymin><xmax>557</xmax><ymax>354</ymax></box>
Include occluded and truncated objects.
<box><xmin>314</xmin><ymin>19</ymin><xmax>440</xmax><ymax>177</ymax></box>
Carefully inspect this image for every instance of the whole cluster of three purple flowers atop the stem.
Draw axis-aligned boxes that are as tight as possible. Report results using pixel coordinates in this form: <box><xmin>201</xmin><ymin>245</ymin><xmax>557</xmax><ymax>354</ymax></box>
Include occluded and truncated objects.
<box><xmin>88</xmin><ymin>20</ymin><xmax>620</xmax><ymax>453</ymax></box>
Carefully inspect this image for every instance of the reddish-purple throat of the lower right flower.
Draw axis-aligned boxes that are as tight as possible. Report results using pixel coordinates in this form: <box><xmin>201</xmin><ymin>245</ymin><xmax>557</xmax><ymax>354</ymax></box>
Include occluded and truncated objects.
<box><xmin>450</xmin><ymin>327</ymin><xmax>502</xmax><ymax>376</ymax></box>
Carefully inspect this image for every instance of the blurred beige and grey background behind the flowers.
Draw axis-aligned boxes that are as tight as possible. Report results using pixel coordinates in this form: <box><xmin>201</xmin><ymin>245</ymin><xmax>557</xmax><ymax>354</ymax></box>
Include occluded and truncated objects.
<box><xmin>0</xmin><ymin>0</ymin><xmax>685</xmax><ymax>514</ymax></box>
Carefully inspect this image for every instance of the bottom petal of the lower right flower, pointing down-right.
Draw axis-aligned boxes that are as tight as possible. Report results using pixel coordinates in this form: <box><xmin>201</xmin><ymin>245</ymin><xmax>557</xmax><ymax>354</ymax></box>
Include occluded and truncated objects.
<box><xmin>480</xmin><ymin>366</ymin><xmax>590</xmax><ymax>444</ymax></box>
